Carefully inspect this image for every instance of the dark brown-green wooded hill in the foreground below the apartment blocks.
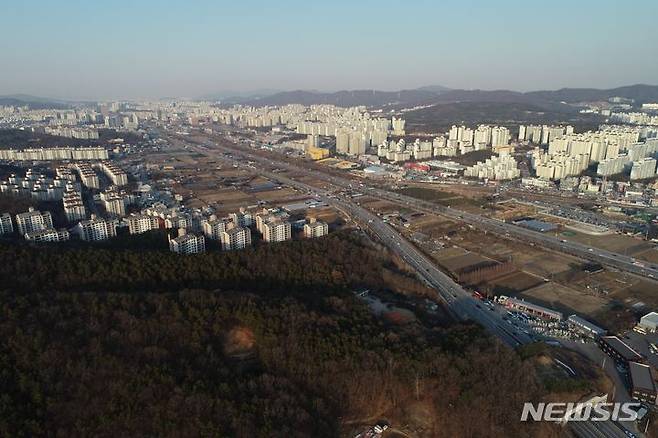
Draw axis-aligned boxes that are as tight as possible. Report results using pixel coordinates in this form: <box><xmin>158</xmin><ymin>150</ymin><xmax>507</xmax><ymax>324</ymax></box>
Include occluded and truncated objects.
<box><xmin>0</xmin><ymin>233</ymin><xmax>553</xmax><ymax>437</ymax></box>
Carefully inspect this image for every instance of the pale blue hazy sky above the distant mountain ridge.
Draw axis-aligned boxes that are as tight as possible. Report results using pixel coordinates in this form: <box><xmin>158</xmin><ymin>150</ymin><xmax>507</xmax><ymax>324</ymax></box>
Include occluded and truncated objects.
<box><xmin>0</xmin><ymin>0</ymin><xmax>658</xmax><ymax>99</ymax></box>
